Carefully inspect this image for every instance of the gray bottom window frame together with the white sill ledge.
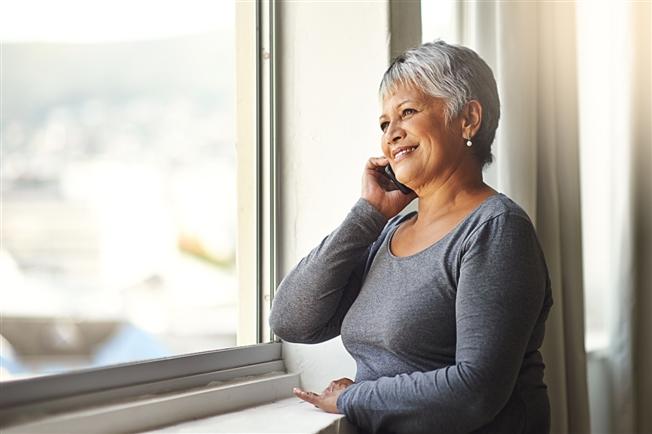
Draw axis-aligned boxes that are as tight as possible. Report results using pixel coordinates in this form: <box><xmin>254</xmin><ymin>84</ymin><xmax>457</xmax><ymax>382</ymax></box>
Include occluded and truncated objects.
<box><xmin>0</xmin><ymin>343</ymin><xmax>357</xmax><ymax>434</ymax></box>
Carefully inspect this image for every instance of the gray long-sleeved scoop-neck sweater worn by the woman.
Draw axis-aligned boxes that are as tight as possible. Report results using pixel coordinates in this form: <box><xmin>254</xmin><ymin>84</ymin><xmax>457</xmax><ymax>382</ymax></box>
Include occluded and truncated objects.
<box><xmin>270</xmin><ymin>194</ymin><xmax>552</xmax><ymax>434</ymax></box>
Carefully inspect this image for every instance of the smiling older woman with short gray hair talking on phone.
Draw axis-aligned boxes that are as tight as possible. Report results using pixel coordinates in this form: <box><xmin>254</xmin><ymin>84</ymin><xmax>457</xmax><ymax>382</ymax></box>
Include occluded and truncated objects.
<box><xmin>270</xmin><ymin>41</ymin><xmax>552</xmax><ymax>434</ymax></box>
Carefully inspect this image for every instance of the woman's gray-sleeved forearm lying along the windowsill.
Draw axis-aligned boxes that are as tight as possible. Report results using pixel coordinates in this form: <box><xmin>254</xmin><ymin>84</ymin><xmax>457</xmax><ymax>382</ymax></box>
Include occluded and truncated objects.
<box><xmin>337</xmin><ymin>364</ymin><xmax>513</xmax><ymax>434</ymax></box>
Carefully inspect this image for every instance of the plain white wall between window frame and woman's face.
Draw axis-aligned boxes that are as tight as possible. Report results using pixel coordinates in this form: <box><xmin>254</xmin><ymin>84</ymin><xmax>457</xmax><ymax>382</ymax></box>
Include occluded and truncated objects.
<box><xmin>277</xmin><ymin>0</ymin><xmax>389</xmax><ymax>391</ymax></box>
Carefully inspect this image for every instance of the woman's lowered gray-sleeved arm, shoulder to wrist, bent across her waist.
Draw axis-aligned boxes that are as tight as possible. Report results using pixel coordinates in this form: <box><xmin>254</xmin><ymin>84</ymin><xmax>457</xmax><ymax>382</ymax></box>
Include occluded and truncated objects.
<box><xmin>337</xmin><ymin>214</ymin><xmax>547</xmax><ymax>433</ymax></box>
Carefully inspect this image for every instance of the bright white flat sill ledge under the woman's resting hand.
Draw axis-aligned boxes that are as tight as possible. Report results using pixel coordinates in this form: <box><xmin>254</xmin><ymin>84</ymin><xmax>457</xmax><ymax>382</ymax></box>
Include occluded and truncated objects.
<box><xmin>147</xmin><ymin>397</ymin><xmax>357</xmax><ymax>434</ymax></box>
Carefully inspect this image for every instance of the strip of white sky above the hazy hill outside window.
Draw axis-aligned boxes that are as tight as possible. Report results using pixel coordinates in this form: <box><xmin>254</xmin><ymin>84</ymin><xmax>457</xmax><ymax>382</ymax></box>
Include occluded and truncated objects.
<box><xmin>0</xmin><ymin>0</ymin><xmax>235</xmax><ymax>43</ymax></box>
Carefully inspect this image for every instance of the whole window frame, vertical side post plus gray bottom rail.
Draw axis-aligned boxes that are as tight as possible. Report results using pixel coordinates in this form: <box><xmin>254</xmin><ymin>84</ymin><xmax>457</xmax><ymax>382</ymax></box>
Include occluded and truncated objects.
<box><xmin>0</xmin><ymin>0</ymin><xmax>282</xmax><ymax>433</ymax></box>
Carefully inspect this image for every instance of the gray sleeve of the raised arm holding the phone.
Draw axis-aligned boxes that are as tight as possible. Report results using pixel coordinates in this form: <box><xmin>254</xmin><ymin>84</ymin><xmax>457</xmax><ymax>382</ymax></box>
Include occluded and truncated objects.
<box><xmin>269</xmin><ymin>199</ymin><xmax>387</xmax><ymax>343</ymax></box>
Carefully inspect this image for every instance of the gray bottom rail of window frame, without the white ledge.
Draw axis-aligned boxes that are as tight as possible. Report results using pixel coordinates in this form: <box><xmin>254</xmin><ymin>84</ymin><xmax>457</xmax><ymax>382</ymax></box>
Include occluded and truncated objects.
<box><xmin>0</xmin><ymin>342</ymin><xmax>299</xmax><ymax>433</ymax></box>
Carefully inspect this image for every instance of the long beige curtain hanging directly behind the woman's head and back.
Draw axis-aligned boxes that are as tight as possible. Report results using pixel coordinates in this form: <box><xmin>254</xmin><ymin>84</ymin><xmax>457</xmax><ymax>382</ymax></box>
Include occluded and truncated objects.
<box><xmin>458</xmin><ymin>1</ymin><xmax>590</xmax><ymax>433</ymax></box>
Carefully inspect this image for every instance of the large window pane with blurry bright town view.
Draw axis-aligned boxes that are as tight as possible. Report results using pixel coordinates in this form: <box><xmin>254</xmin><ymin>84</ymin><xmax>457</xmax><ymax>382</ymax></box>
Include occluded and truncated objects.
<box><xmin>0</xmin><ymin>0</ymin><xmax>242</xmax><ymax>380</ymax></box>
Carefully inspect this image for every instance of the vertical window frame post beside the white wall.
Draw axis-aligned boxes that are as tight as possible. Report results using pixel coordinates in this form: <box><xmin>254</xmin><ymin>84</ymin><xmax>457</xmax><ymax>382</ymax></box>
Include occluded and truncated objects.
<box><xmin>236</xmin><ymin>0</ymin><xmax>279</xmax><ymax>345</ymax></box>
